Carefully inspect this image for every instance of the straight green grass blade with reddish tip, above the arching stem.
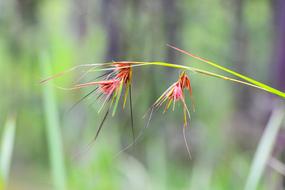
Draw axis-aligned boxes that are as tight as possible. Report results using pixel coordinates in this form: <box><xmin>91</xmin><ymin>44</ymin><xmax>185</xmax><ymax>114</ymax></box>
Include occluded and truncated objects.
<box><xmin>168</xmin><ymin>45</ymin><xmax>285</xmax><ymax>98</ymax></box>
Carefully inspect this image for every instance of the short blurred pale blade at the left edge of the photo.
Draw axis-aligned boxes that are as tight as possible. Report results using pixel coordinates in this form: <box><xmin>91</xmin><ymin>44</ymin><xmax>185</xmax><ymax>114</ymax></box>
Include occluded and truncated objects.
<box><xmin>0</xmin><ymin>115</ymin><xmax>16</xmax><ymax>190</ymax></box>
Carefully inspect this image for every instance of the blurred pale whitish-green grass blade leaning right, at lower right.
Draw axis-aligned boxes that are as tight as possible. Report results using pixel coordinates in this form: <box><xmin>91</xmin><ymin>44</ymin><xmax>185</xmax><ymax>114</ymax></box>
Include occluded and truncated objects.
<box><xmin>244</xmin><ymin>106</ymin><xmax>285</xmax><ymax>190</ymax></box>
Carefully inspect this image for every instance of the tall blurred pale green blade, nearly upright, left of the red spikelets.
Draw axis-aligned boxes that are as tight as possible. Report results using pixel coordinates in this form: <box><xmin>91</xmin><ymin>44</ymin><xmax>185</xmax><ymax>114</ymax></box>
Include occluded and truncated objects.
<box><xmin>39</xmin><ymin>52</ymin><xmax>66</xmax><ymax>190</ymax></box>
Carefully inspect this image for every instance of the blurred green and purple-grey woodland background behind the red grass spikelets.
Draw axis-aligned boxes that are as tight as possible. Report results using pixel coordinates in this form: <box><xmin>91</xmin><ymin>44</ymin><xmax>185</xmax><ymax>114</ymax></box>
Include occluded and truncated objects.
<box><xmin>0</xmin><ymin>0</ymin><xmax>285</xmax><ymax>190</ymax></box>
